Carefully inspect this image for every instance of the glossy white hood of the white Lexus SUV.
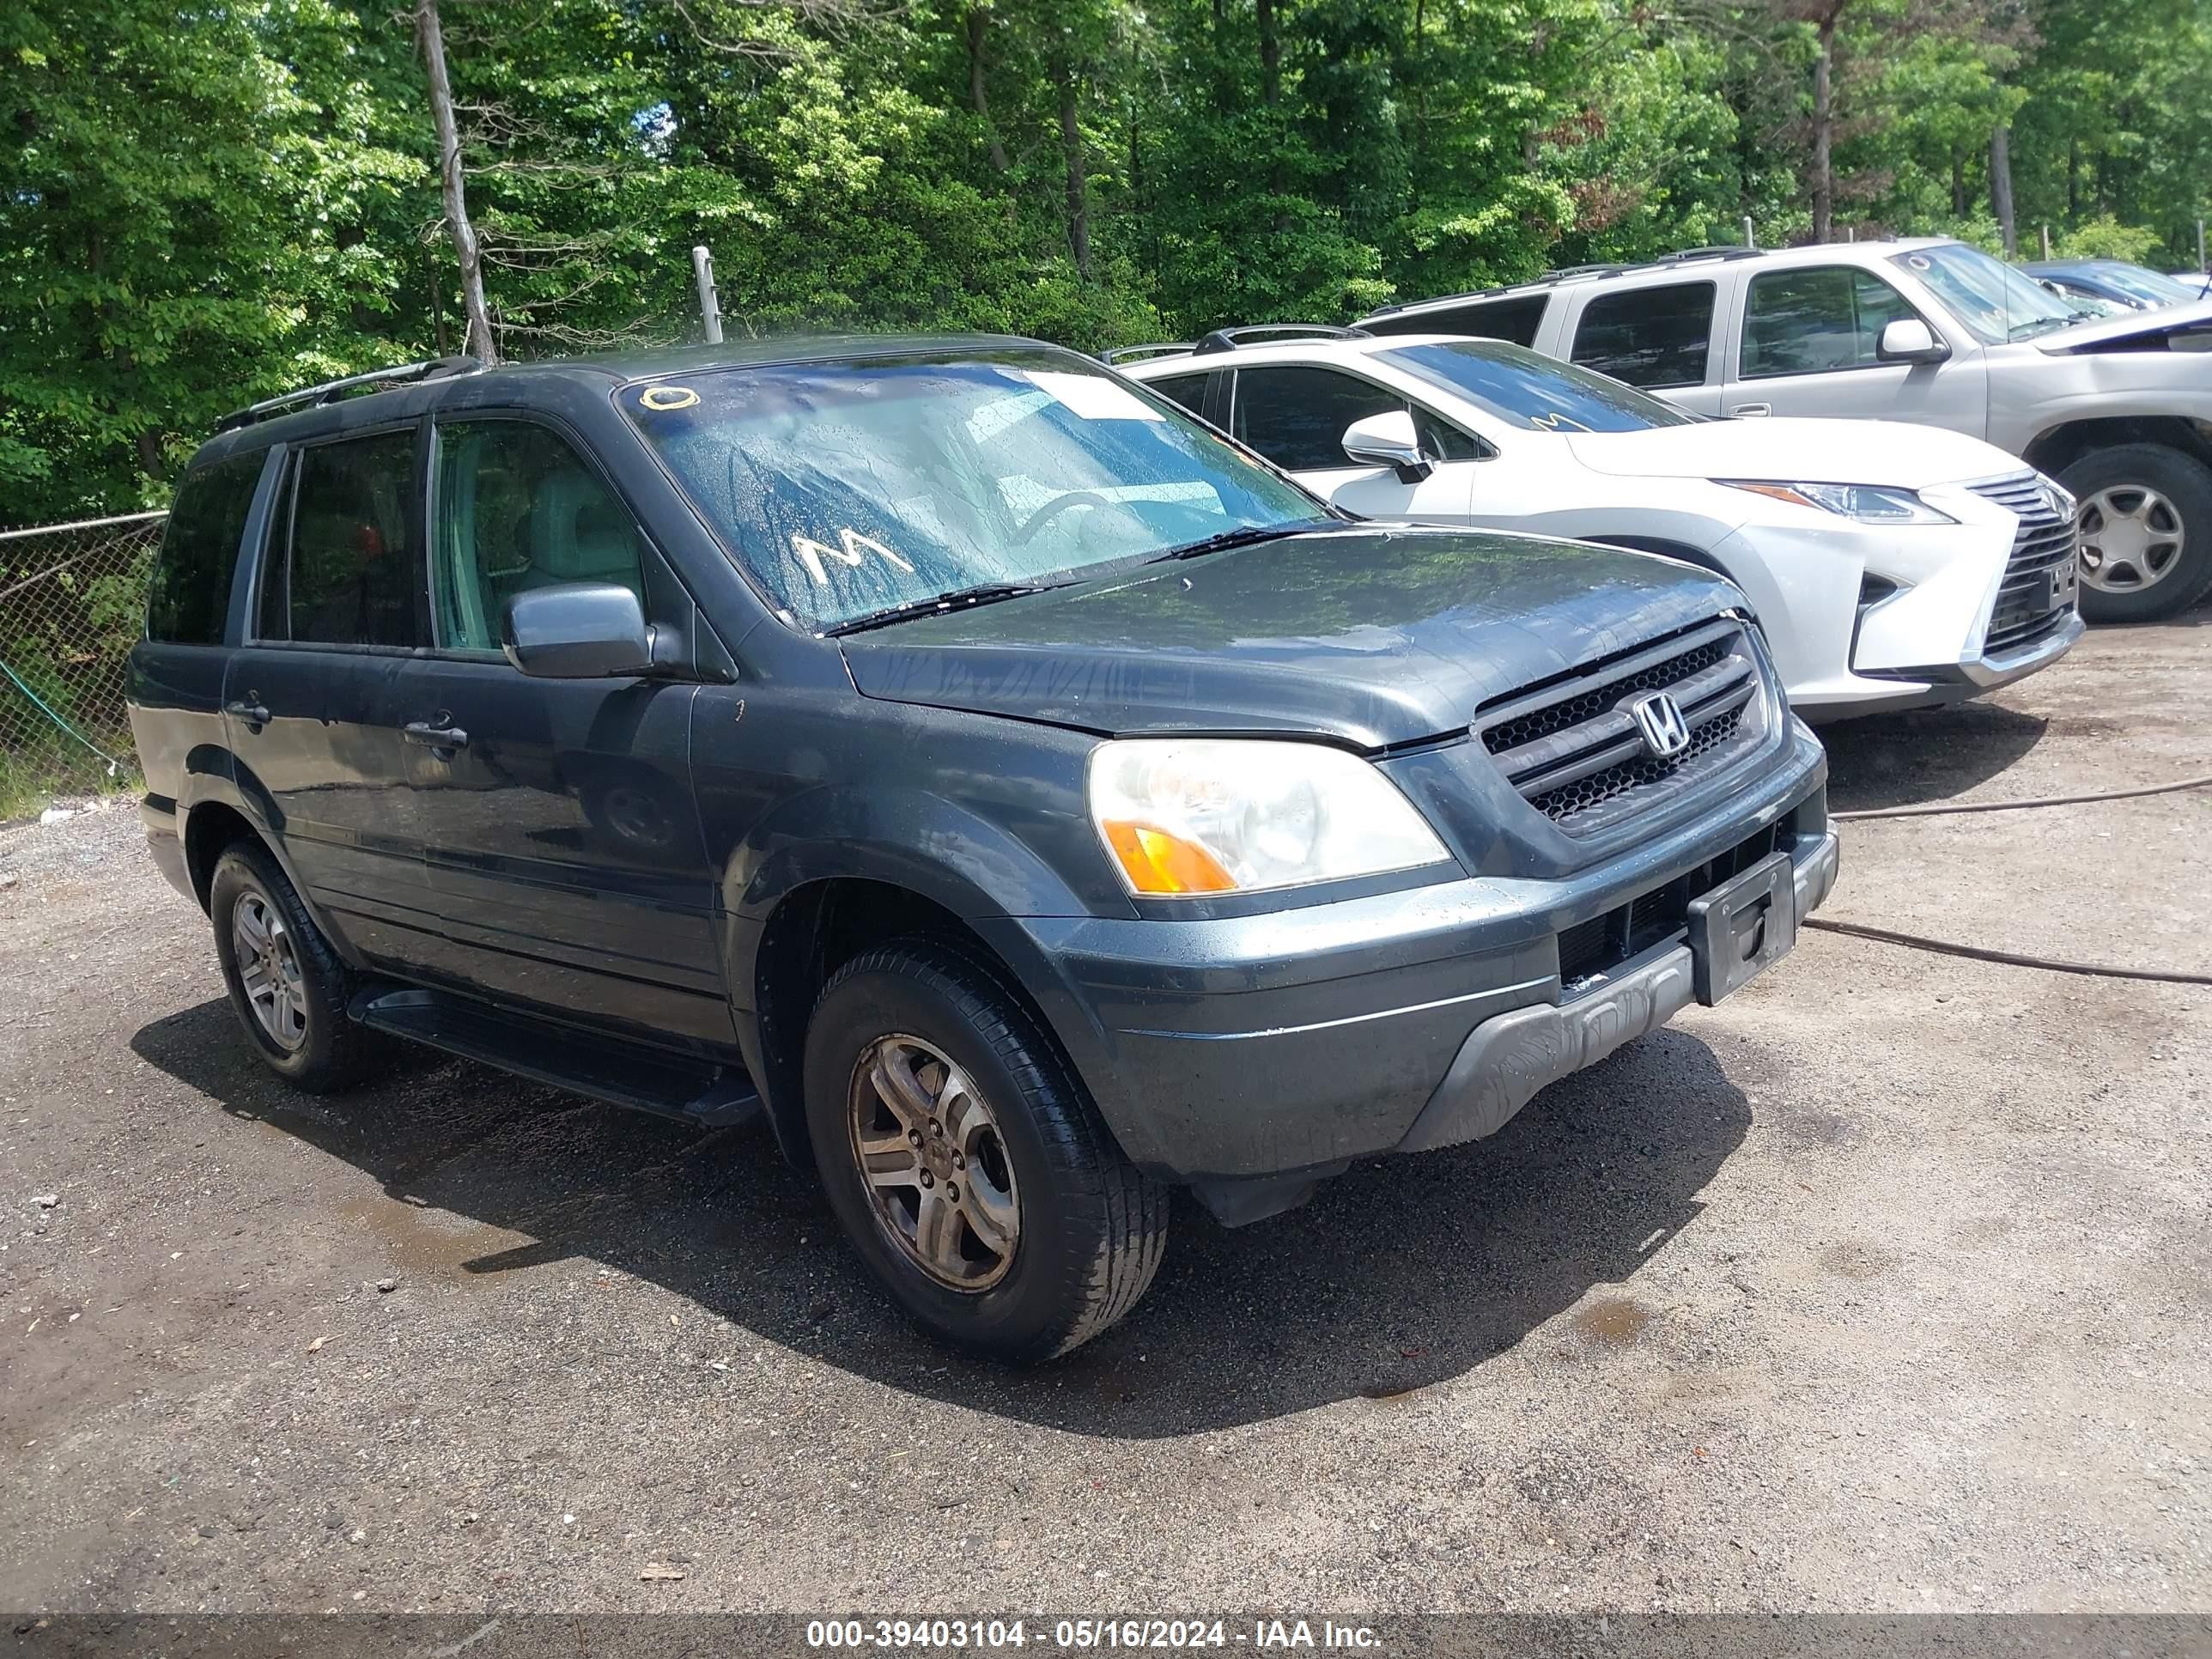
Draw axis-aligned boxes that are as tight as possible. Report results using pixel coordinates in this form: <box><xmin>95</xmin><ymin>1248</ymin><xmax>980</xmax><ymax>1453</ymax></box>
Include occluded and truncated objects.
<box><xmin>1566</xmin><ymin>416</ymin><xmax>2020</xmax><ymax>489</ymax></box>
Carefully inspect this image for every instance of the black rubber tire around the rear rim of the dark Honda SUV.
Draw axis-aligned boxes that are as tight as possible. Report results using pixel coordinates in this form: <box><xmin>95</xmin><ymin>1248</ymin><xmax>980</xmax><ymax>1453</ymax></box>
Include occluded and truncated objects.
<box><xmin>208</xmin><ymin>841</ymin><xmax>383</xmax><ymax>1095</ymax></box>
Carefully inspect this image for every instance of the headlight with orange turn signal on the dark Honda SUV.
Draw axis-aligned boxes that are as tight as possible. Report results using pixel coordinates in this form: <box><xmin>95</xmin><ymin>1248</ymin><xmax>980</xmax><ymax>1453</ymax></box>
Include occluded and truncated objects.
<box><xmin>1088</xmin><ymin>738</ymin><xmax>1451</xmax><ymax>894</ymax></box>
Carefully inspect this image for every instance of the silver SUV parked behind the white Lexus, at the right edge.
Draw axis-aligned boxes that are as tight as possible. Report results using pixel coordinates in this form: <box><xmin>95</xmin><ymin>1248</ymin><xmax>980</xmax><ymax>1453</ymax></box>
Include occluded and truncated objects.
<box><xmin>1360</xmin><ymin>239</ymin><xmax>2212</xmax><ymax>622</ymax></box>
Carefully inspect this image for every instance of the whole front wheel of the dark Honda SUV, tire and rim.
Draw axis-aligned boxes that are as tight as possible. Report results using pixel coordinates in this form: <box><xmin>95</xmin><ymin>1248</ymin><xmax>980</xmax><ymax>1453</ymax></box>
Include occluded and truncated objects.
<box><xmin>805</xmin><ymin>940</ymin><xmax>1168</xmax><ymax>1363</ymax></box>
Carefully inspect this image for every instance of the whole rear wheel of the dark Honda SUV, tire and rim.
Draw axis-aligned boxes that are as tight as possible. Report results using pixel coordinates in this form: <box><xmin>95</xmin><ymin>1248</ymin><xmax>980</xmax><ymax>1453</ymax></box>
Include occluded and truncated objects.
<box><xmin>208</xmin><ymin>841</ymin><xmax>378</xmax><ymax>1095</ymax></box>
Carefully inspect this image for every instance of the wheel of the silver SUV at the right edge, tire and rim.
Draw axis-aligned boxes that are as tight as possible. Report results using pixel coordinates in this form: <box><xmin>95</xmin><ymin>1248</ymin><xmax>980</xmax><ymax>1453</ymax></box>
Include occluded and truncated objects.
<box><xmin>2059</xmin><ymin>445</ymin><xmax>2212</xmax><ymax>622</ymax></box>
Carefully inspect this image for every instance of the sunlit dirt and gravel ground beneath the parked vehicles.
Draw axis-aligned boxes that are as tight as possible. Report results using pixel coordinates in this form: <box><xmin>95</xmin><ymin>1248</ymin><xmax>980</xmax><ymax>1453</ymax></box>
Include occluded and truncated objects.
<box><xmin>0</xmin><ymin>622</ymin><xmax>2212</xmax><ymax>1613</ymax></box>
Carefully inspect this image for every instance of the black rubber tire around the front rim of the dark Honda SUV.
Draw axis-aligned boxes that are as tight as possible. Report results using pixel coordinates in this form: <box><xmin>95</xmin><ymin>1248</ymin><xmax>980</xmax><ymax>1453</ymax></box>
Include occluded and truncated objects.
<box><xmin>805</xmin><ymin>940</ymin><xmax>1168</xmax><ymax>1364</ymax></box>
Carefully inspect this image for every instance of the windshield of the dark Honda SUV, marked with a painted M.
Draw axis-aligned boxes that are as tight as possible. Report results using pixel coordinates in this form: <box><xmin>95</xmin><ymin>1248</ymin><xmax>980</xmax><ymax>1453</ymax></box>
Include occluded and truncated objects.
<box><xmin>617</xmin><ymin>347</ymin><xmax>1334</xmax><ymax>630</ymax></box>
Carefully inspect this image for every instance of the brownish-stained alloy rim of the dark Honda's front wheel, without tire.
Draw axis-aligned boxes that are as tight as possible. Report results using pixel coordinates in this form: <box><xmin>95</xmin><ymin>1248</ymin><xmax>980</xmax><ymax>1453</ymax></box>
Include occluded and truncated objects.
<box><xmin>848</xmin><ymin>1036</ymin><xmax>1022</xmax><ymax>1291</ymax></box>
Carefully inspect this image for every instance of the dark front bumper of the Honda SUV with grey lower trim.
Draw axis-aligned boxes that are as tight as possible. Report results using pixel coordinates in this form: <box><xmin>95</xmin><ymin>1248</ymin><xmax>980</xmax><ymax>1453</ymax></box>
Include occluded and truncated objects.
<box><xmin>995</xmin><ymin>730</ymin><xmax>1836</xmax><ymax>1221</ymax></box>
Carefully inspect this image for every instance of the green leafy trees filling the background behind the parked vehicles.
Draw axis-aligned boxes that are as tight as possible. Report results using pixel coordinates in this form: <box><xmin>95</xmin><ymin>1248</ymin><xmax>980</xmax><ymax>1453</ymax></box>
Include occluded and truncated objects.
<box><xmin>0</xmin><ymin>0</ymin><xmax>2212</xmax><ymax>522</ymax></box>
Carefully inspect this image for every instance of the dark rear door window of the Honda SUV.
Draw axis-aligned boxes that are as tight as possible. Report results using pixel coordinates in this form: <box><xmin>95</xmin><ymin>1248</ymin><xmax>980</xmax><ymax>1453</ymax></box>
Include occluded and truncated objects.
<box><xmin>261</xmin><ymin>431</ymin><xmax>429</xmax><ymax>646</ymax></box>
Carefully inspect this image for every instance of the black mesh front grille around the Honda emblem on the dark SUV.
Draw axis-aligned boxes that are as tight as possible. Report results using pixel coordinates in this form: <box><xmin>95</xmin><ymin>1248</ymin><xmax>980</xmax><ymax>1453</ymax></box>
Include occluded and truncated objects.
<box><xmin>1475</xmin><ymin>617</ymin><xmax>1765</xmax><ymax>836</ymax></box>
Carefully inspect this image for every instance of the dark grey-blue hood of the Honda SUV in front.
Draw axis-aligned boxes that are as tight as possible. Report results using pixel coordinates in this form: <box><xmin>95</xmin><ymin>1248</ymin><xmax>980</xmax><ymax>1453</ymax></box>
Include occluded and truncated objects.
<box><xmin>838</xmin><ymin>525</ymin><xmax>1743</xmax><ymax>750</ymax></box>
